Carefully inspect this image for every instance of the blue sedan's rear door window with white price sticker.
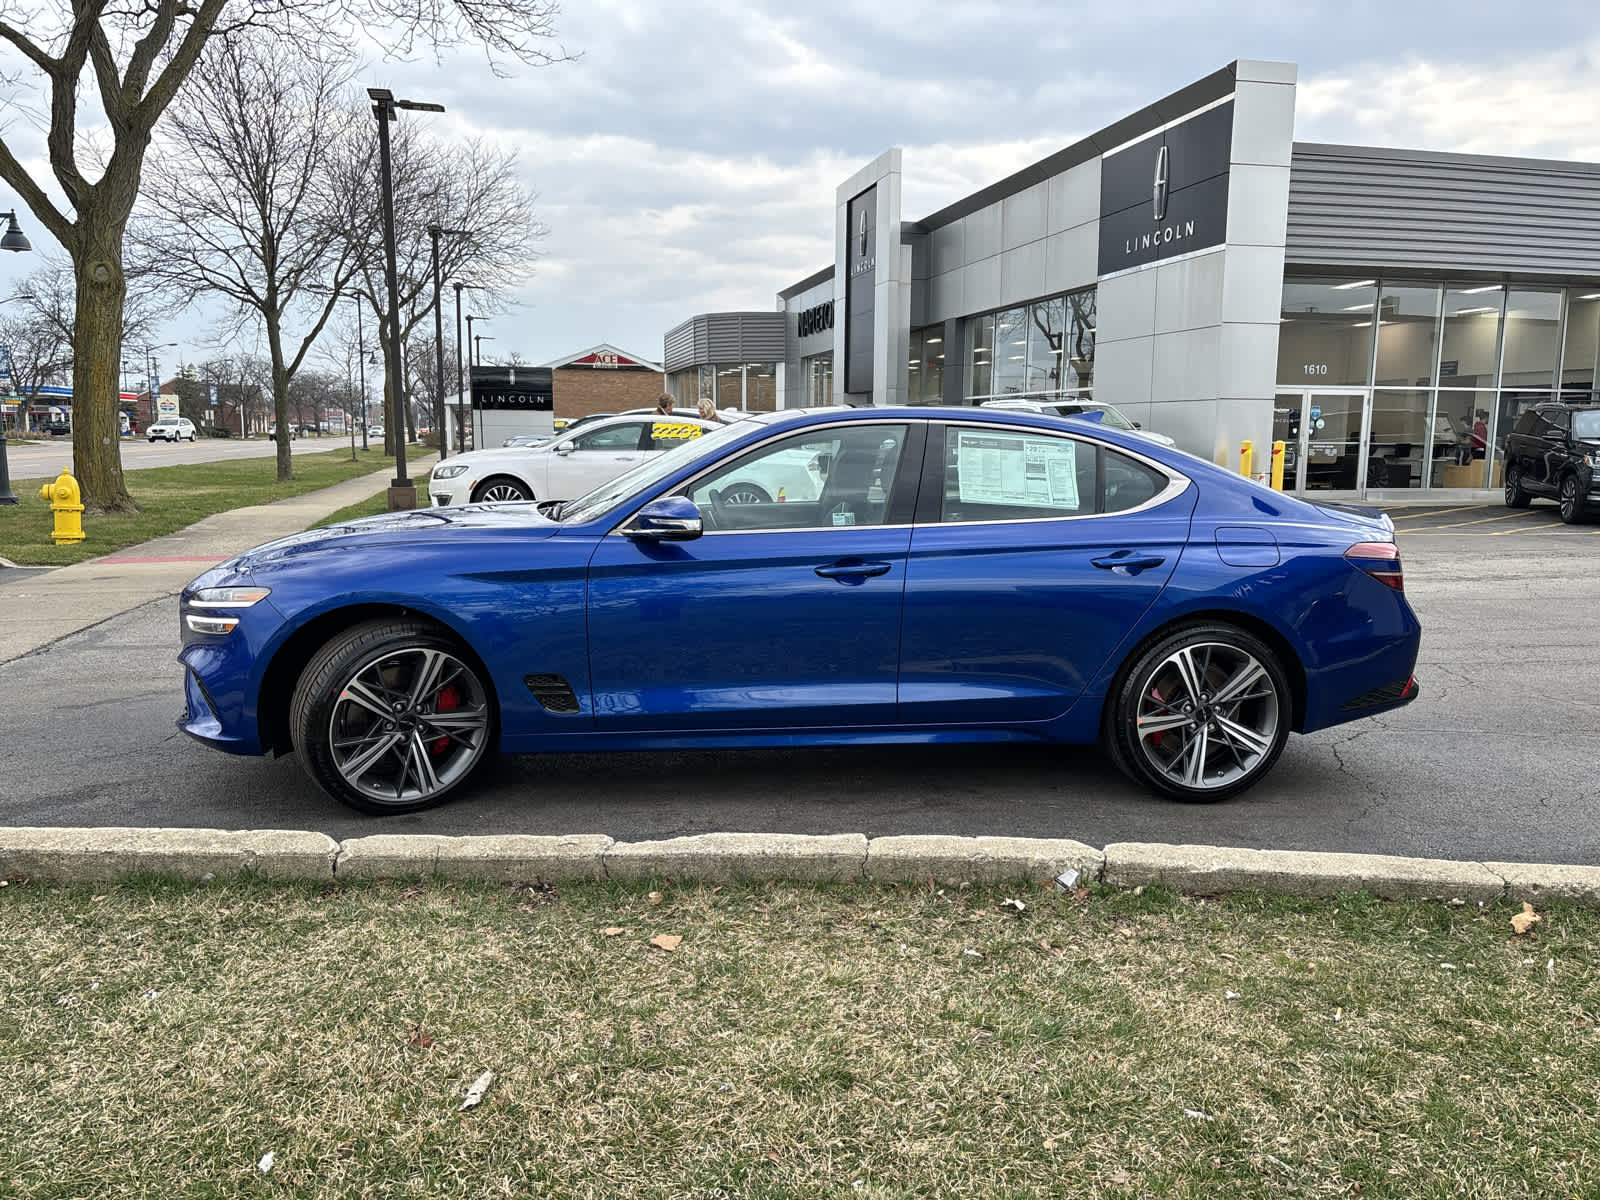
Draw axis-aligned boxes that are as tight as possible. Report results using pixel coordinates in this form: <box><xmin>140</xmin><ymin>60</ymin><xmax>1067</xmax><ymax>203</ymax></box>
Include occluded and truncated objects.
<box><xmin>939</xmin><ymin>426</ymin><xmax>1099</xmax><ymax>522</ymax></box>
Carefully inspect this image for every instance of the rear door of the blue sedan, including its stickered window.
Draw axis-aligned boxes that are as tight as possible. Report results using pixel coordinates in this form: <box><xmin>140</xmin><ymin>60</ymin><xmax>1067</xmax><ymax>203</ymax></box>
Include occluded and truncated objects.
<box><xmin>899</xmin><ymin>422</ymin><xmax>1197</xmax><ymax>725</ymax></box>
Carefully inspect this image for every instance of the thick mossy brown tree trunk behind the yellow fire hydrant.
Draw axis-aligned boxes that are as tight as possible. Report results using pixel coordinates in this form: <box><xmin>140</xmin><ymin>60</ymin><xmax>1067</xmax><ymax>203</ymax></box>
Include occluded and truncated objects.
<box><xmin>72</xmin><ymin>214</ymin><xmax>139</xmax><ymax>512</ymax></box>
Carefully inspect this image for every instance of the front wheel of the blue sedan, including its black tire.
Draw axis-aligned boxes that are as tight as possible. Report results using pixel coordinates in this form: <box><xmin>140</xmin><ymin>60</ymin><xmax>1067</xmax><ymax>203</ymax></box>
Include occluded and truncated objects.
<box><xmin>290</xmin><ymin>619</ymin><xmax>499</xmax><ymax>814</ymax></box>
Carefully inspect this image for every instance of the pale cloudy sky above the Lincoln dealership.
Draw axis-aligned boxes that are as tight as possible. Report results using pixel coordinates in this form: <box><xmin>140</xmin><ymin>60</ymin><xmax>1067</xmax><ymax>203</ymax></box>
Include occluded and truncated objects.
<box><xmin>0</xmin><ymin>0</ymin><xmax>1600</xmax><ymax>373</ymax></box>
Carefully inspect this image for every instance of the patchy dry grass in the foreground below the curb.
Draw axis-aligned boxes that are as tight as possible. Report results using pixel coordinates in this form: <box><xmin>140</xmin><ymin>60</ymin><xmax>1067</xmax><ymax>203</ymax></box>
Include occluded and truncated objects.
<box><xmin>0</xmin><ymin>882</ymin><xmax>1600</xmax><ymax>1200</ymax></box>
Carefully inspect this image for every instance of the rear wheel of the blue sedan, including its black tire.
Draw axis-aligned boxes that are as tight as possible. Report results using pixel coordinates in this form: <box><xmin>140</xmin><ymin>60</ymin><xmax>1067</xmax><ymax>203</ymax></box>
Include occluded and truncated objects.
<box><xmin>1102</xmin><ymin>624</ymin><xmax>1294</xmax><ymax>803</ymax></box>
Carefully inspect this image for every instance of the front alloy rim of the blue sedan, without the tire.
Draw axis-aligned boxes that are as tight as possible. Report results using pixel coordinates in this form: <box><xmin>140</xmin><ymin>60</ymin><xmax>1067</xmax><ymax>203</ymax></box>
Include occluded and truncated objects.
<box><xmin>328</xmin><ymin>646</ymin><xmax>490</xmax><ymax>805</ymax></box>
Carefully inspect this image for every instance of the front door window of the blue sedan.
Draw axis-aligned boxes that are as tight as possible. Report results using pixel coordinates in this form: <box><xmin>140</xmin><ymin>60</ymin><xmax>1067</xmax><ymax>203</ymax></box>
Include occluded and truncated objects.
<box><xmin>683</xmin><ymin>424</ymin><xmax>907</xmax><ymax>531</ymax></box>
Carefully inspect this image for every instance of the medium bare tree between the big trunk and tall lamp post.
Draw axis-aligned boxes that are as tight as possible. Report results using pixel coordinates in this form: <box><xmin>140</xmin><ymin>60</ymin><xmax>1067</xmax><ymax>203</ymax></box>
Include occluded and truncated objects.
<box><xmin>130</xmin><ymin>30</ymin><xmax>366</xmax><ymax>480</ymax></box>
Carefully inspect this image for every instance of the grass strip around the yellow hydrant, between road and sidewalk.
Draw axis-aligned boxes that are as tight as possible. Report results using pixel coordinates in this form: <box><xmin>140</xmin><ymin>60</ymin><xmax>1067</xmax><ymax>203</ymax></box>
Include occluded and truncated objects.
<box><xmin>0</xmin><ymin>445</ymin><xmax>389</xmax><ymax>566</ymax></box>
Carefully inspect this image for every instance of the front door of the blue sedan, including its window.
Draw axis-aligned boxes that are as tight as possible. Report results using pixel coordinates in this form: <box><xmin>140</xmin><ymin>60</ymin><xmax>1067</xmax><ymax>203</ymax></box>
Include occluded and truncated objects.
<box><xmin>589</xmin><ymin>419</ymin><xmax>923</xmax><ymax>731</ymax></box>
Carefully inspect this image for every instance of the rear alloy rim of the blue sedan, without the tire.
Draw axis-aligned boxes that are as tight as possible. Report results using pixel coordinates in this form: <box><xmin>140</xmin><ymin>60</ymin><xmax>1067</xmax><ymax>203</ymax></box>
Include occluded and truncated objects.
<box><xmin>1134</xmin><ymin>642</ymin><xmax>1283</xmax><ymax>792</ymax></box>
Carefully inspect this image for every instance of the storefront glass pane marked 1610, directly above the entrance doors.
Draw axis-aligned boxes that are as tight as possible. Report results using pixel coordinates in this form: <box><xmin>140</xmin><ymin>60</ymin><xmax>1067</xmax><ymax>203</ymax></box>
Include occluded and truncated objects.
<box><xmin>1278</xmin><ymin>278</ymin><xmax>1378</xmax><ymax>387</ymax></box>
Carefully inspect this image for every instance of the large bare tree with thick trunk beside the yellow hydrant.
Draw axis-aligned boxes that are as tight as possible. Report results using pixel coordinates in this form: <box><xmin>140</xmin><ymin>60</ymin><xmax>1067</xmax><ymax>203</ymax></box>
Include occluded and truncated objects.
<box><xmin>0</xmin><ymin>0</ymin><xmax>563</xmax><ymax>510</ymax></box>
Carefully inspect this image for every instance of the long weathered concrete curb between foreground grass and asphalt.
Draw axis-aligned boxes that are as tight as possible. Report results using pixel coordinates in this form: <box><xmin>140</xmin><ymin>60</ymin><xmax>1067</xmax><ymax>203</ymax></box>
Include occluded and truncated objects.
<box><xmin>0</xmin><ymin>827</ymin><xmax>1600</xmax><ymax>906</ymax></box>
